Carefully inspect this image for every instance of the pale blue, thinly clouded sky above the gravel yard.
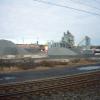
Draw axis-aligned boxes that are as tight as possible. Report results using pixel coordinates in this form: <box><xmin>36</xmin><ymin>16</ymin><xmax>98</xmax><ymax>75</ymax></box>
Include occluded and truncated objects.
<box><xmin>0</xmin><ymin>0</ymin><xmax>100</xmax><ymax>45</ymax></box>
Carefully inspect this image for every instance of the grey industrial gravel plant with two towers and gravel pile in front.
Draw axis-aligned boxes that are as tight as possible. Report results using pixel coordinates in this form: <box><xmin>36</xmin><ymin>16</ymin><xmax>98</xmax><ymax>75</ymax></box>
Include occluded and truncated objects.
<box><xmin>48</xmin><ymin>31</ymin><xmax>94</xmax><ymax>56</ymax></box>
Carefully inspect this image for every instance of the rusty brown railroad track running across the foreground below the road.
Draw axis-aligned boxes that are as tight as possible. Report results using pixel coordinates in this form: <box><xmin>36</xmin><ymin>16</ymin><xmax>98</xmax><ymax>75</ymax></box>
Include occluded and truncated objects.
<box><xmin>0</xmin><ymin>71</ymin><xmax>100</xmax><ymax>100</ymax></box>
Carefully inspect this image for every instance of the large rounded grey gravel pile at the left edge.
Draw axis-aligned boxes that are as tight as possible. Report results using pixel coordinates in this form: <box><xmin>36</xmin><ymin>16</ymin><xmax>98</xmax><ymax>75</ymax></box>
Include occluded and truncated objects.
<box><xmin>0</xmin><ymin>40</ymin><xmax>29</xmax><ymax>56</ymax></box>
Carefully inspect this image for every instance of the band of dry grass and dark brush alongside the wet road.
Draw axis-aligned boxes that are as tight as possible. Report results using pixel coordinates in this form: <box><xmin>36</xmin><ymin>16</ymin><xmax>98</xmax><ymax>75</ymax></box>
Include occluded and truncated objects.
<box><xmin>0</xmin><ymin>59</ymin><xmax>96</xmax><ymax>72</ymax></box>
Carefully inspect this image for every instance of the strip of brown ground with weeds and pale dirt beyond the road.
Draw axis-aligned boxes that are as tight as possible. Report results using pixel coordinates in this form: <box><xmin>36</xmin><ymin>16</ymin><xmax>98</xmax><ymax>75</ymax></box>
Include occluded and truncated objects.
<box><xmin>0</xmin><ymin>58</ymin><xmax>99</xmax><ymax>73</ymax></box>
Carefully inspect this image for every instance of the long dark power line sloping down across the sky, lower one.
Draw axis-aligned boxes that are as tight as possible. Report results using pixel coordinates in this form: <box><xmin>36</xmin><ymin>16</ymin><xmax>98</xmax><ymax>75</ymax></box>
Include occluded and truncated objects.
<box><xmin>33</xmin><ymin>0</ymin><xmax>100</xmax><ymax>16</ymax></box>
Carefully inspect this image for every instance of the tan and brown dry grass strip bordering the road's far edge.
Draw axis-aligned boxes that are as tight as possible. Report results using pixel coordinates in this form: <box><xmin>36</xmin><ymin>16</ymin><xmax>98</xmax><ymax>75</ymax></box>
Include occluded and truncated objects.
<box><xmin>0</xmin><ymin>59</ymin><xmax>97</xmax><ymax>73</ymax></box>
